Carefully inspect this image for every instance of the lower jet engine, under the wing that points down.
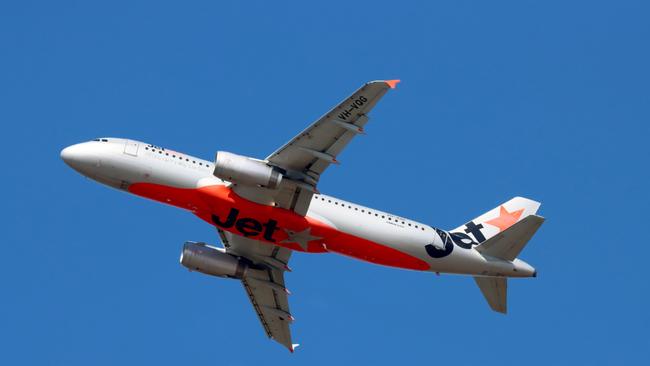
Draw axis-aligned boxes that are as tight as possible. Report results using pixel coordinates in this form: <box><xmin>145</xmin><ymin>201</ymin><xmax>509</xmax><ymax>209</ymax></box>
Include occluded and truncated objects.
<box><xmin>181</xmin><ymin>241</ymin><xmax>248</xmax><ymax>278</ymax></box>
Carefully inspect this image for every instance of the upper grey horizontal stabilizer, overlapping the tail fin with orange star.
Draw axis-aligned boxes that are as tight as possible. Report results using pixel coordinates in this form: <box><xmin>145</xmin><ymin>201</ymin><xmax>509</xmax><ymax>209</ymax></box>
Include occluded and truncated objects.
<box><xmin>476</xmin><ymin>215</ymin><xmax>544</xmax><ymax>262</ymax></box>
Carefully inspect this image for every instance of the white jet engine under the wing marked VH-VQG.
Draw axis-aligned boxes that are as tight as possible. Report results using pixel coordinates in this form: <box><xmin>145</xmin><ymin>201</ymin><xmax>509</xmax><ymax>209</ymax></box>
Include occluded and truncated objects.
<box><xmin>213</xmin><ymin>151</ymin><xmax>282</xmax><ymax>189</ymax></box>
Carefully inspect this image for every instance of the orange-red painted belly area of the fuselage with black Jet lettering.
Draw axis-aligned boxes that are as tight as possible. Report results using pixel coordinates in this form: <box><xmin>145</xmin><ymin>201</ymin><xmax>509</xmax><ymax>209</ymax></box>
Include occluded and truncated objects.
<box><xmin>129</xmin><ymin>183</ymin><xmax>430</xmax><ymax>270</ymax></box>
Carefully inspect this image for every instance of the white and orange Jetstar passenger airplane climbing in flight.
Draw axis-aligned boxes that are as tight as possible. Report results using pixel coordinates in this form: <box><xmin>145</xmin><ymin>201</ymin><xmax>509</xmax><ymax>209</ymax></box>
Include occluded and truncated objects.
<box><xmin>61</xmin><ymin>80</ymin><xmax>544</xmax><ymax>352</ymax></box>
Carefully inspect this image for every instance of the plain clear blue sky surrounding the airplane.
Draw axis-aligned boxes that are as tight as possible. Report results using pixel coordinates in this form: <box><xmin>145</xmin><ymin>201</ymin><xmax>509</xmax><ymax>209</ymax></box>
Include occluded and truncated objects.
<box><xmin>0</xmin><ymin>1</ymin><xmax>650</xmax><ymax>365</ymax></box>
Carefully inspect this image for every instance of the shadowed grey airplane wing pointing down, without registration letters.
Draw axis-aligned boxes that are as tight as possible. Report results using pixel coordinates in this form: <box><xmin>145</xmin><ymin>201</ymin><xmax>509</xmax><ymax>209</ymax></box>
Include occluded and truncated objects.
<box><xmin>219</xmin><ymin>230</ymin><xmax>297</xmax><ymax>352</ymax></box>
